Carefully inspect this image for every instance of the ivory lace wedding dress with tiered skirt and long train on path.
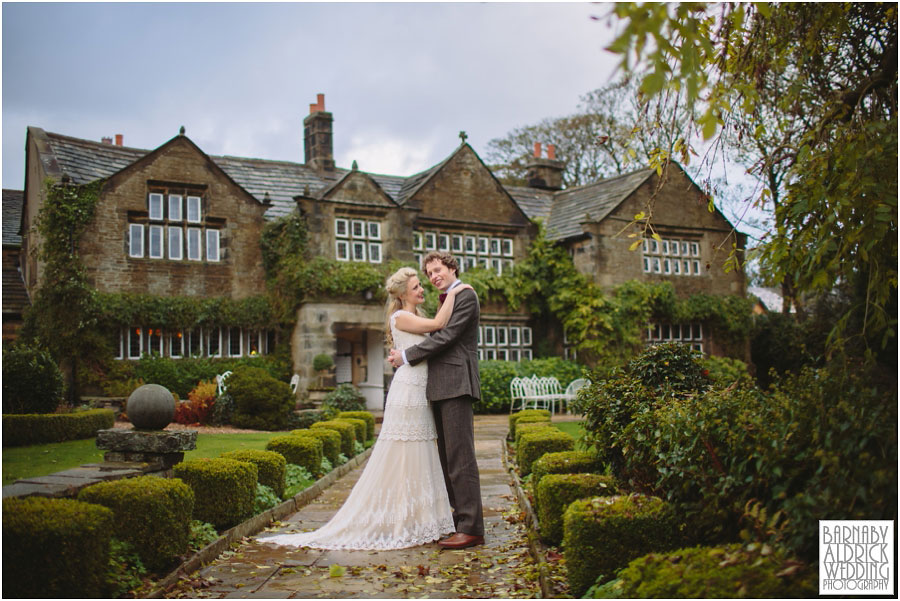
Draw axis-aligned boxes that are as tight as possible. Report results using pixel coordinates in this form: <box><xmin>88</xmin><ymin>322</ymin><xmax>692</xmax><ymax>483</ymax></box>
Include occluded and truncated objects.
<box><xmin>259</xmin><ymin>311</ymin><xmax>454</xmax><ymax>550</ymax></box>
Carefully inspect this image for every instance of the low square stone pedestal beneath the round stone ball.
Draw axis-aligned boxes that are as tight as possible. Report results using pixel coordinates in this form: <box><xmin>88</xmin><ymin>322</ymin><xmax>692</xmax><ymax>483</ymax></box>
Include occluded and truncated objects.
<box><xmin>97</xmin><ymin>428</ymin><xmax>197</xmax><ymax>470</ymax></box>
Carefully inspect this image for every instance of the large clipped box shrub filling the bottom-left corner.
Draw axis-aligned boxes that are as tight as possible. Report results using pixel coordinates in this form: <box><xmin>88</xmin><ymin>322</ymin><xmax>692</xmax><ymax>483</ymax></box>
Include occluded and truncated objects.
<box><xmin>3</xmin><ymin>497</ymin><xmax>115</xmax><ymax>599</ymax></box>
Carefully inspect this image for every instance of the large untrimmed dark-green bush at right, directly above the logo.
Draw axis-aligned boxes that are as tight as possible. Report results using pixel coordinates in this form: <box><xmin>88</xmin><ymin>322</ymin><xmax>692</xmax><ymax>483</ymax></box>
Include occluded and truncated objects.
<box><xmin>636</xmin><ymin>370</ymin><xmax>897</xmax><ymax>561</ymax></box>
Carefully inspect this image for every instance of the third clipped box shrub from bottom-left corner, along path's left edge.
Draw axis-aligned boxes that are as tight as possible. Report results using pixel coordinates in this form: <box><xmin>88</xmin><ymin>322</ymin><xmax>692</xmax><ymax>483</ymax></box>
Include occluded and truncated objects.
<box><xmin>173</xmin><ymin>458</ymin><xmax>257</xmax><ymax>529</ymax></box>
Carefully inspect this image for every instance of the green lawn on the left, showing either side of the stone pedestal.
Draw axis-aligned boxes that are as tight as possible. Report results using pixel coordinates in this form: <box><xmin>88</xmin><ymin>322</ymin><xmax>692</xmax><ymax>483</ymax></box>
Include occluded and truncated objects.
<box><xmin>3</xmin><ymin>432</ymin><xmax>284</xmax><ymax>486</ymax></box>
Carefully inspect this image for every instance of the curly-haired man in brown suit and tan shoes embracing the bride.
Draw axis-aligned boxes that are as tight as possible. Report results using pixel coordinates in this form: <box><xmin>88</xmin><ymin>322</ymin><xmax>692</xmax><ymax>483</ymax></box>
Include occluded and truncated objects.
<box><xmin>389</xmin><ymin>252</ymin><xmax>484</xmax><ymax>549</ymax></box>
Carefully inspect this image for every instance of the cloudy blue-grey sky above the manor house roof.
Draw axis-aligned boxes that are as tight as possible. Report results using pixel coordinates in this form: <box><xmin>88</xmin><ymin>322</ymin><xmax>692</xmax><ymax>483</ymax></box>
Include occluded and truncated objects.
<box><xmin>2</xmin><ymin>2</ymin><xmax>617</xmax><ymax>189</ymax></box>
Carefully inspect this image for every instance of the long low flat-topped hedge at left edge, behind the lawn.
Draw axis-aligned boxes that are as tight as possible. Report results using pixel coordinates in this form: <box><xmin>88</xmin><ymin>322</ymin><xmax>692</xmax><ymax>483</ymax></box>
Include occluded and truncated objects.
<box><xmin>3</xmin><ymin>409</ymin><xmax>116</xmax><ymax>447</ymax></box>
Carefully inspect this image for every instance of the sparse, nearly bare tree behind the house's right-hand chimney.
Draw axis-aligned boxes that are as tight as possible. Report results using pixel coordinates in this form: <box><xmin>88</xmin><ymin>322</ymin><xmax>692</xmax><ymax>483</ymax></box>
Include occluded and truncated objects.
<box><xmin>485</xmin><ymin>78</ymin><xmax>689</xmax><ymax>187</ymax></box>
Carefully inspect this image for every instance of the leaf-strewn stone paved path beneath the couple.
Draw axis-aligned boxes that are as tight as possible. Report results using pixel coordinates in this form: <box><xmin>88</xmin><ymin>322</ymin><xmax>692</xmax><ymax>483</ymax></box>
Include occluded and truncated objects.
<box><xmin>167</xmin><ymin>415</ymin><xmax>540</xmax><ymax>599</ymax></box>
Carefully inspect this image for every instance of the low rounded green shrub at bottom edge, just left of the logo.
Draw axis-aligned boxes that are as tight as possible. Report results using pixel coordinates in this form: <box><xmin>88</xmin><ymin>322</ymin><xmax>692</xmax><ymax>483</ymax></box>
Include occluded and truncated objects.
<box><xmin>587</xmin><ymin>544</ymin><xmax>818</xmax><ymax>599</ymax></box>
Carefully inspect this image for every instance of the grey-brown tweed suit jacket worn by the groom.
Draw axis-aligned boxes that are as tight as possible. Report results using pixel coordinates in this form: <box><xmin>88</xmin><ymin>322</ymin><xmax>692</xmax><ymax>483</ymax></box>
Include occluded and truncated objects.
<box><xmin>406</xmin><ymin>290</ymin><xmax>481</xmax><ymax>401</ymax></box>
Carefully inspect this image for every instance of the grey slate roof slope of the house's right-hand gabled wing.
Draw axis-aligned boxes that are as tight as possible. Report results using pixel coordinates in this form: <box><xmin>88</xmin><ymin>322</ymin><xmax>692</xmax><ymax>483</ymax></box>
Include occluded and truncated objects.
<box><xmin>547</xmin><ymin>169</ymin><xmax>653</xmax><ymax>240</ymax></box>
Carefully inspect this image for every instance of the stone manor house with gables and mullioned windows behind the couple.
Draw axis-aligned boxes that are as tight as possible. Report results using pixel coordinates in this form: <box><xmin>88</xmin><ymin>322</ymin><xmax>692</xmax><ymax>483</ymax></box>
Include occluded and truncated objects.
<box><xmin>3</xmin><ymin>94</ymin><xmax>746</xmax><ymax>408</ymax></box>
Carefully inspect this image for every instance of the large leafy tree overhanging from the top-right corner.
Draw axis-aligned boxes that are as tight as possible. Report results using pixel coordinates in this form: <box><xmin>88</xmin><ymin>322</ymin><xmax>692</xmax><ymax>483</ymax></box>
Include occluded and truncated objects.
<box><xmin>609</xmin><ymin>2</ymin><xmax>898</xmax><ymax>359</ymax></box>
